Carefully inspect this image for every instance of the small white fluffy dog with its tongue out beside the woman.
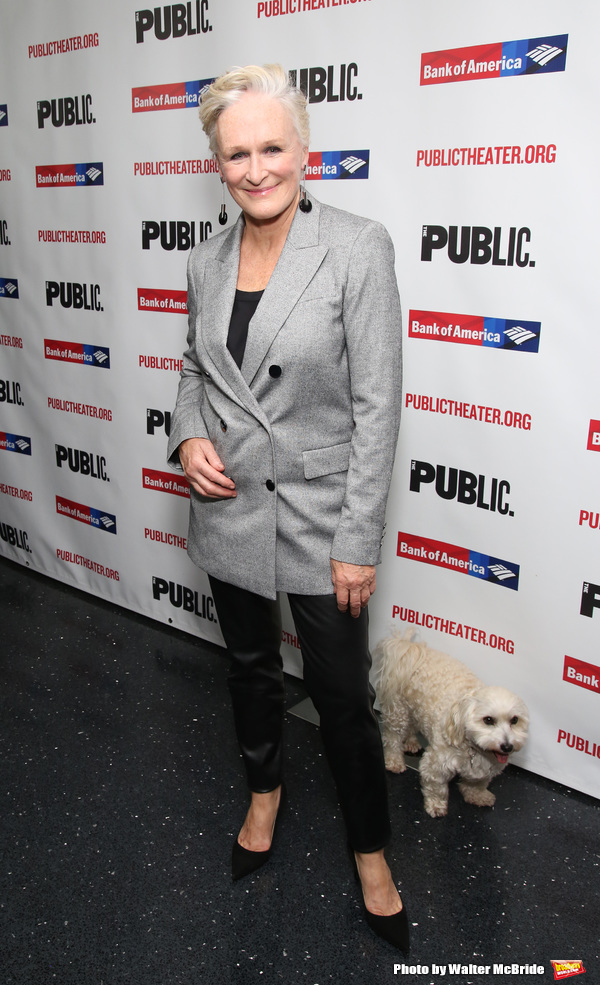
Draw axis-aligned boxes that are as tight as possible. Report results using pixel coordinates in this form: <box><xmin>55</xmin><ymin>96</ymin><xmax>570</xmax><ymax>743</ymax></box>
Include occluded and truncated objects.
<box><xmin>375</xmin><ymin>636</ymin><xmax>529</xmax><ymax>817</ymax></box>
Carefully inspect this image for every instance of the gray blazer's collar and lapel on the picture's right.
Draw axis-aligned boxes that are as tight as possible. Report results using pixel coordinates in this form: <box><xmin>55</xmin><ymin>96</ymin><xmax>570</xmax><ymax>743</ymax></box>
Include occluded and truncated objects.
<box><xmin>236</xmin><ymin>199</ymin><xmax>328</xmax><ymax>386</ymax></box>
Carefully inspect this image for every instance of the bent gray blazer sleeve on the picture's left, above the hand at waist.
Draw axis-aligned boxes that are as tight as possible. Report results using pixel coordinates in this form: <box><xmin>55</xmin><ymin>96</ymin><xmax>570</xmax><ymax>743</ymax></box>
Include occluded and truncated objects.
<box><xmin>167</xmin><ymin>251</ymin><xmax>208</xmax><ymax>471</ymax></box>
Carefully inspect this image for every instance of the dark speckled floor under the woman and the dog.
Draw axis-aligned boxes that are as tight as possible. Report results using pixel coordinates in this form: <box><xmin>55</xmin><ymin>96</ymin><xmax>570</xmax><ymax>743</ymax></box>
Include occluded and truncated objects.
<box><xmin>0</xmin><ymin>560</ymin><xmax>600</xmax><ymax>985</ymax></box>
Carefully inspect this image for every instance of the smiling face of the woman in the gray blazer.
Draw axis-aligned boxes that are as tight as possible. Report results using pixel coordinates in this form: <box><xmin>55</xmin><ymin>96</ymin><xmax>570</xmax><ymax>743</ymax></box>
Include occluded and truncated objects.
<box><xmin>216</xmin><ymin>92</ymin><xmax>308</xmax><ymax>222</ymax></box>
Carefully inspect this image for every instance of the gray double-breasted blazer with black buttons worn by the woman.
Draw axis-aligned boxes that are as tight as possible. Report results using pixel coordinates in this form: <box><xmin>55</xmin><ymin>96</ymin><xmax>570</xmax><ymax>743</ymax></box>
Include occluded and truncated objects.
<box><xmin>167</xmin><ymin>189</ymin><xmax>401</xmax><ymax>598</ymax></box>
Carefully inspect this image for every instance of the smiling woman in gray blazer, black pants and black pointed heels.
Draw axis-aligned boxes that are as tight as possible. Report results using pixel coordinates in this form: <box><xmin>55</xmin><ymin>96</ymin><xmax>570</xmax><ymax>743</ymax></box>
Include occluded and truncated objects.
<box><xmin>168</xmin><ymin>65</ymin><xmax>408</xmax><ymax>949</ymax></box>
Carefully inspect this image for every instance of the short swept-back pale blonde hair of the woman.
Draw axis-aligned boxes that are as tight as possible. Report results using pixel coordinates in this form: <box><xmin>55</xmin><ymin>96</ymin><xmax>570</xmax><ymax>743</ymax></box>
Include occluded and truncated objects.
<box><xmin>199</xmin><ymin>65</ymin><xmax>310</xmax><ymax>154</ymax></box>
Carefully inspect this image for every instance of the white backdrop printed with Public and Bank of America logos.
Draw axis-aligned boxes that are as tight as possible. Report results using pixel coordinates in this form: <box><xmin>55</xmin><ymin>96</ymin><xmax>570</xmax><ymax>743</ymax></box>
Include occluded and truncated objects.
<box><xmin>0</xmin><ymin>0</ymin><xmax>600</xmax><ymax>796</ymax></box>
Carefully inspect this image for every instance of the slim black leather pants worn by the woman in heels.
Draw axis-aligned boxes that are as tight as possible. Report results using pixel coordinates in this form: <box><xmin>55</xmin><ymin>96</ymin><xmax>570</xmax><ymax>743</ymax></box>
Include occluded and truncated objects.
<box><xmin>210</xmin><ymin>577</ymin><xmax>390</xmax><ymax>852</ymax></box>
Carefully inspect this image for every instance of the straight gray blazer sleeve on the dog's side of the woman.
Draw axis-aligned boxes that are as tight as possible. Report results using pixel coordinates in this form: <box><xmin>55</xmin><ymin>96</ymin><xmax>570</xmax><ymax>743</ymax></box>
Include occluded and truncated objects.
<box><xmin>331</xmin><ymin>222</ymin><xmax>402</xmax><ymax>564</ymax></box>
